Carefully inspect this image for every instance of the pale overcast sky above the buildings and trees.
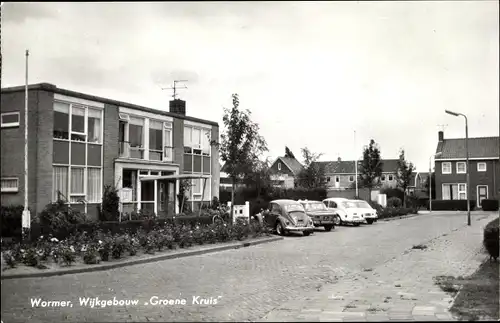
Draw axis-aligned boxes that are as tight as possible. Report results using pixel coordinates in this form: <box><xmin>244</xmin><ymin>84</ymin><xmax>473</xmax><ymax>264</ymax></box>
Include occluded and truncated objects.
<box><xmin>1</xmin><ymin>1</ymin><xmax>499</xmax><ymax>171</ymax></box>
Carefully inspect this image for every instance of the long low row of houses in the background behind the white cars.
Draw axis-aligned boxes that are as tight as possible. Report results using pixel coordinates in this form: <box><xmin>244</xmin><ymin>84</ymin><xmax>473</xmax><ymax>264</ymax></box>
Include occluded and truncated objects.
<box><xmin>316</xmin><ymin>158</ymin><xmax>398</xmax><ymax>190</ymax></box>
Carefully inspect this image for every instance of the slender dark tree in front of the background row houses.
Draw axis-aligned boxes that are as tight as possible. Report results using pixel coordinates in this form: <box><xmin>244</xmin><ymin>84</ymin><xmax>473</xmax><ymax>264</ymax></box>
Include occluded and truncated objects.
<box><xmin>359</xmin><ymin>139</ymin><xmax>383</xmax><ymax>197</ymax></box>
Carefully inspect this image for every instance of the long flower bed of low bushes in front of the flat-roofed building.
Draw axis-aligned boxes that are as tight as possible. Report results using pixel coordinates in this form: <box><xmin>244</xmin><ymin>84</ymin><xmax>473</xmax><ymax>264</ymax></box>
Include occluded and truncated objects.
<box><xmin>2</xmin><ymin>218</ymin><xmax>270</xmax><ymax>270</ymax></box>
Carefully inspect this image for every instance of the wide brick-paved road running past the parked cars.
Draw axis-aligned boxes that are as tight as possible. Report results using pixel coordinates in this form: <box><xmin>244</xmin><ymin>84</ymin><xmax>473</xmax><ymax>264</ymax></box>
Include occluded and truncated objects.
<box><xmin>1</xmin><ymin>213</ymin><xmax>491</xmax><ymax>322</ymax></box>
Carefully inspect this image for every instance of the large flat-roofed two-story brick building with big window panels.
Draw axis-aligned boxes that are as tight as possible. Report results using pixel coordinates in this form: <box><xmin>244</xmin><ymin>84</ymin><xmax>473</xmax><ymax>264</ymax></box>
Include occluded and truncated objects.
<box><xmin>0</xmin><ymin>83</ymin><xmax>220</xmax><ymax>218</ymax></box>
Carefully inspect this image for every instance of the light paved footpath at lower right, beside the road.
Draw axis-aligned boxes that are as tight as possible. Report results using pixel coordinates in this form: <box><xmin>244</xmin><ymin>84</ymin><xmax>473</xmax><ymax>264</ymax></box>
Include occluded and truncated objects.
<box><xmin>260</xmin><ymin>214</ymin><xmax>498</xmax><ymax>321</ymax></box>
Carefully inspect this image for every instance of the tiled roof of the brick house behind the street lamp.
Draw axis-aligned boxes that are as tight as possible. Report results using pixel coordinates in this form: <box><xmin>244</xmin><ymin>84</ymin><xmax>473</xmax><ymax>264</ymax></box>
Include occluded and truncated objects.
<box><xmin>436</xmin><ymin>137</ymin><xmax>500</xmax><ymax>159</ymax></box>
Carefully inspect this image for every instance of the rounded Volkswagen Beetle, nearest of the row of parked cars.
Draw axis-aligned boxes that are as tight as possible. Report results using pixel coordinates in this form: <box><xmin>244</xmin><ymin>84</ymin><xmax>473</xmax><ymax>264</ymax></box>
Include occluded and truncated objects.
<box><xmin>256</xmin><ymin>200</ymin><xmax>314</xmax><ymax>236</ymax></box>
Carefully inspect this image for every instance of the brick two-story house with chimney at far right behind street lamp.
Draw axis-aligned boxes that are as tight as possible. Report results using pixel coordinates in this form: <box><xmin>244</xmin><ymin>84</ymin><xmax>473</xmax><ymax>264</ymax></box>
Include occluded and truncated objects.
<box><xmin>435</xmin><ymin>131</ymin><xmax>500</xmax><ymax>206</ymax></box>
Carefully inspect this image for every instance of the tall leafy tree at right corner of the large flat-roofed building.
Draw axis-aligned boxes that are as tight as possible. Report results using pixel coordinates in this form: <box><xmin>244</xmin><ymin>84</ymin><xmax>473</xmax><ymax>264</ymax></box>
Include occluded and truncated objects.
<box><xmin>211</xmin><ymin>94</ymin><xmax>267</xmax><ymax>220</ymax></box>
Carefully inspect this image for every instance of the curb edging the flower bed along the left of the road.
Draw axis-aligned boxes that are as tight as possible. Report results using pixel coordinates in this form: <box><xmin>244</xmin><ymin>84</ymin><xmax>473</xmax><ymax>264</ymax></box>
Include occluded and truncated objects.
<box><xmin>1</xmin><ymin>237</ymin><xmax>284</xmax><ymax>280</ymax></box>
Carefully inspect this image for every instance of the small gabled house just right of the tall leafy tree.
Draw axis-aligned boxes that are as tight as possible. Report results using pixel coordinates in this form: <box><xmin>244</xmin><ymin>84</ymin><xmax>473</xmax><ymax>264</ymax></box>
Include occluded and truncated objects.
<box><xmin>269</xmin><ymin>155</ymin><xmax>304</xmax><ymax>188</ymax></box>
